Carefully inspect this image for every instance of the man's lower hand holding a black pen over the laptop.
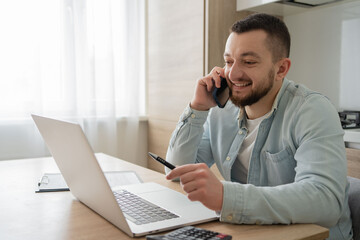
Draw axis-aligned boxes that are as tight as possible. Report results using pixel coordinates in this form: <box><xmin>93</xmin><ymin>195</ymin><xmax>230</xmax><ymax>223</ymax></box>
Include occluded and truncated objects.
<box><xmin>166</xmin><ymin>163</ymin><xmax>224</xmax><ymax>211</ymax></box>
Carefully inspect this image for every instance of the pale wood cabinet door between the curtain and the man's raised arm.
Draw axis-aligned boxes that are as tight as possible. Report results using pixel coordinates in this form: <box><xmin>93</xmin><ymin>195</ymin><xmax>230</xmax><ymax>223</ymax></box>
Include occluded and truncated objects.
<box><xmin>147</xmin><ymin>0</ymin><xmax>205</xmax><ymax>172</ymax></box>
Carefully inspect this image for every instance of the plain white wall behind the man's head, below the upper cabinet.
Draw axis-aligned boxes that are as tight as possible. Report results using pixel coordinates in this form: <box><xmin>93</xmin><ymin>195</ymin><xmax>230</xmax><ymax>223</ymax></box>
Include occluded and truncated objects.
<box><xmin>284</xmin><ymin>1</ymin><xmax>360</xmax><ymax>111</ymax></box>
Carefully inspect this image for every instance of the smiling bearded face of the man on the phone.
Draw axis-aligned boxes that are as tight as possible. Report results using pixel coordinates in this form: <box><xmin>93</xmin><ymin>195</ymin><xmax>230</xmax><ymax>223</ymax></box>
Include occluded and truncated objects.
<box><xmin>224</xmin><ymin>30</ymin><xmax>275</xmax><ymax>107</ymax></box>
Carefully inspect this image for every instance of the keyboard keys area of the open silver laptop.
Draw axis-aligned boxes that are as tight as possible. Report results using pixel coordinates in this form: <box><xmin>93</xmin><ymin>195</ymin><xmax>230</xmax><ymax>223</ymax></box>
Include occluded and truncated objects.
<box><xmin>114</xmin><ymin>190</ymin><xmax>179</xmax><ymax>225</ymax></box>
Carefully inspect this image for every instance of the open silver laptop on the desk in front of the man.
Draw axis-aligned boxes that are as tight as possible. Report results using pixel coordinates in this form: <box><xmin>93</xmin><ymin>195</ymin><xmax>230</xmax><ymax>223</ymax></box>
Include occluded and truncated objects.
<box><xmin>32</xmin><ymin>115</ymin><xmax>218</xmax><ymax>237</ymax></box>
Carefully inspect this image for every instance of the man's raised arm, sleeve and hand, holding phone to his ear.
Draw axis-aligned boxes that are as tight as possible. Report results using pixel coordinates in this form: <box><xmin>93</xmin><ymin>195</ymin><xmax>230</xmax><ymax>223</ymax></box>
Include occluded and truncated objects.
<box><xmin>165</xmin><ymin>67</ymin><xmax>224</xmax><ymax>173</ymax></box>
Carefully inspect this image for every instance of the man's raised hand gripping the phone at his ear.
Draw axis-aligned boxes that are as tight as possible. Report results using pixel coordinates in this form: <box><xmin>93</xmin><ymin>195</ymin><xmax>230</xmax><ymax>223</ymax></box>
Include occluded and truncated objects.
<box><xmin>190</xmin><ymin>67</ymin><xmax>225</xmax><ymax>111</ymax></box>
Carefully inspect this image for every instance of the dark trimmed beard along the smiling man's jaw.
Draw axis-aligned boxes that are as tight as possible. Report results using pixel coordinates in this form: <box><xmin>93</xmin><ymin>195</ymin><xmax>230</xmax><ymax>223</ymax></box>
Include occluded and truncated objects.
<box><xmin>229</xmin><ymin>69</ymin><xmax>275</xmax><ymax>107</ymax></box>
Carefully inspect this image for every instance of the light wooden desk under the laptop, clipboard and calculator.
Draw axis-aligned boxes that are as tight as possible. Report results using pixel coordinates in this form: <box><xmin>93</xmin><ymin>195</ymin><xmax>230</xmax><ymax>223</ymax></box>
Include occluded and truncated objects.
<box><xmin>0</xmin><ymin>154</ymin><xmax>329</xmax><ymax>240</ymax></box>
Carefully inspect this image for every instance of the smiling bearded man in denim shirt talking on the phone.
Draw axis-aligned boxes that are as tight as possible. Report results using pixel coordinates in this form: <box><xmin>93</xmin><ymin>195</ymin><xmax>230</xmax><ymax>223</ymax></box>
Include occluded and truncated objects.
<box><xmin>167</xmin><ymin>14</ymin><xmax>352</xmax><ymax>240</ymax></box>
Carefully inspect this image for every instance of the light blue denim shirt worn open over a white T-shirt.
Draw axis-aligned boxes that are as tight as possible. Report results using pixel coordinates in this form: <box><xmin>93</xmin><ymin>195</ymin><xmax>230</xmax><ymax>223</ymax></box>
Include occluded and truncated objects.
<box><xmin>166</xmin><ymin>79</ymin><xmax>352</xmax><ymax>240</ymax></box>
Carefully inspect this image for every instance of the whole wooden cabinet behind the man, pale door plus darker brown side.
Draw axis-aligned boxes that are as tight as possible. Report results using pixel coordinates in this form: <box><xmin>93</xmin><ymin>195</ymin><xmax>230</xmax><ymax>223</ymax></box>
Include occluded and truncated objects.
<box><xmin>147</xmin><ymin>0</ymin><xmax>253</xmax><ymax>172</ymax></box>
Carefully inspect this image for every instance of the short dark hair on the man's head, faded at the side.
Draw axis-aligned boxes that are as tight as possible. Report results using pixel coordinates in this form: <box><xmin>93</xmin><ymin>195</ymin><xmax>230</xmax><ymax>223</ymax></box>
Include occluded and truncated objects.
<box><xmin>231</xmin><ymin>13</ymin><xmax>291</xmax><ymax>62</ymax></box>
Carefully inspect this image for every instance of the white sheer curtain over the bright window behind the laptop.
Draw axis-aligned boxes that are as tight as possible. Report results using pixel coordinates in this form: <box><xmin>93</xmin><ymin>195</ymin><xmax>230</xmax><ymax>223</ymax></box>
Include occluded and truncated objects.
<box><xmin>0</xmin><ymin>0</ymin><xmax>145</xmax><ymax>165</ymax></box>
